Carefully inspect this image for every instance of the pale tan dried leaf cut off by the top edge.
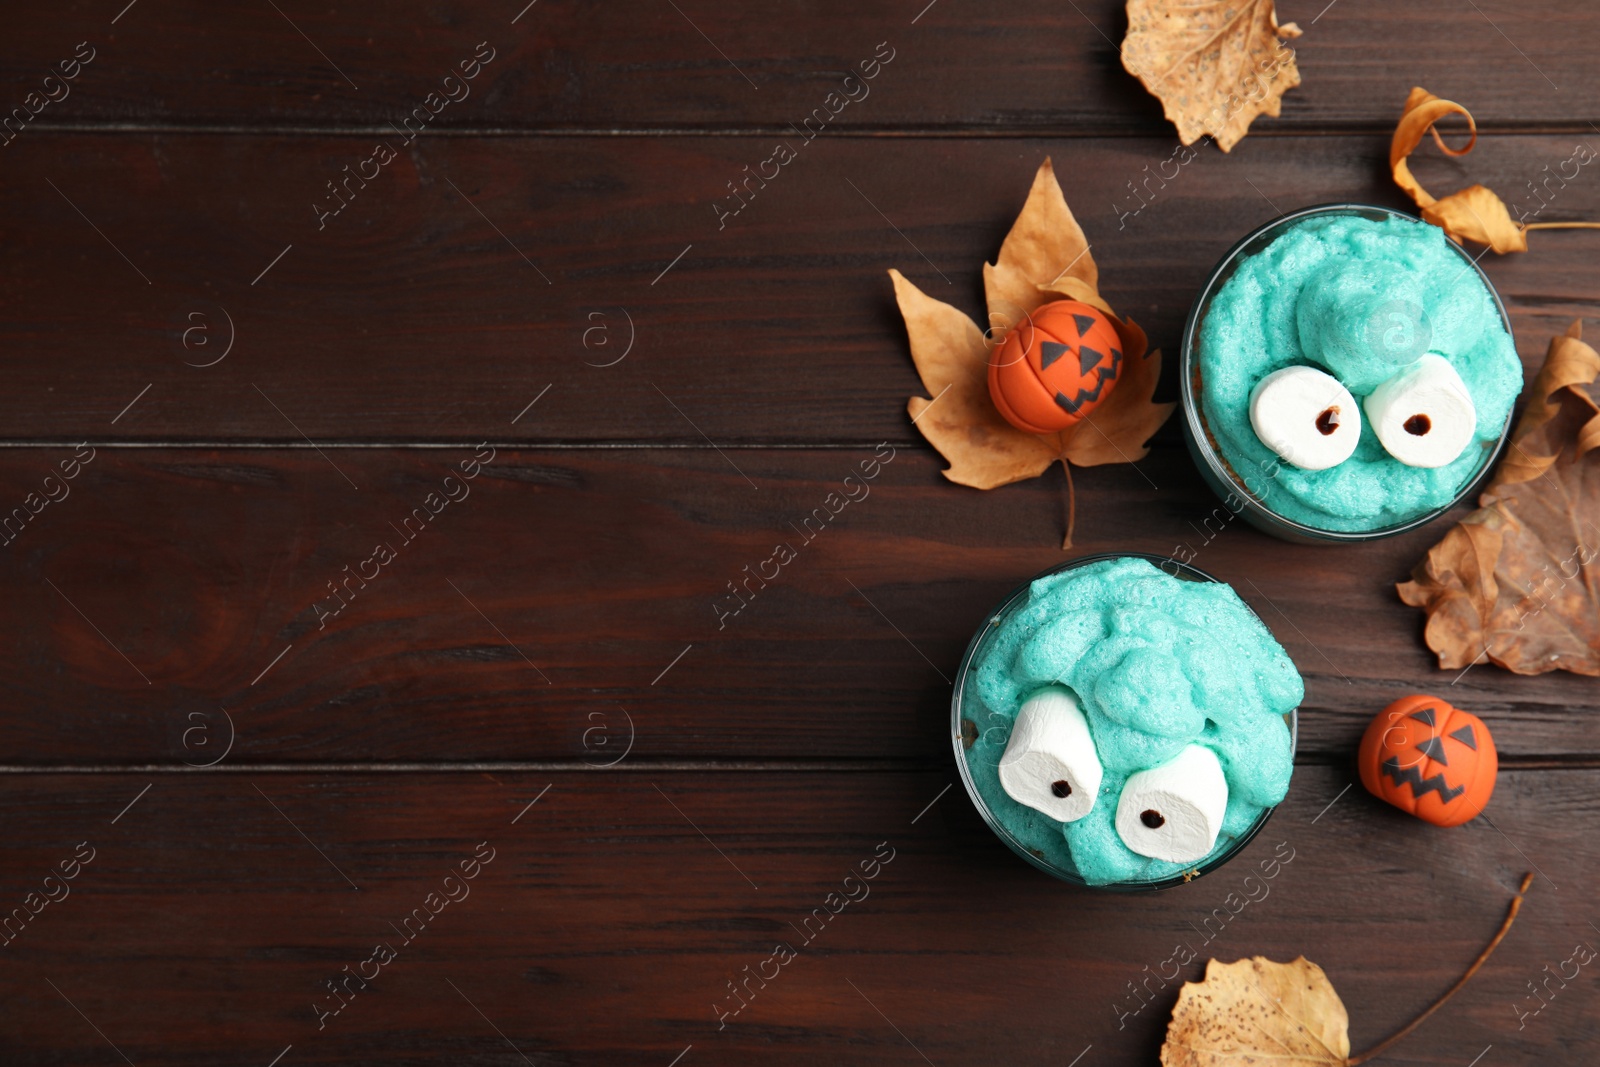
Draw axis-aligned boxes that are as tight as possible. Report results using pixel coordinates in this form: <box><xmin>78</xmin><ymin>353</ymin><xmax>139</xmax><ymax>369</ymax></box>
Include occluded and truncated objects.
<box><xmin>1122</xmin><ymin>0</ymin><xmax>1301</xmax><ymax>152</ymax></box>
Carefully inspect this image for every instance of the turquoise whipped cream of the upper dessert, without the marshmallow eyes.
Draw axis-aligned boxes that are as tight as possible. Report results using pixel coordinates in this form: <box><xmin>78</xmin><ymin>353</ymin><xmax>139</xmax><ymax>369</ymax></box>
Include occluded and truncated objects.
<box><xmin>1197</xmin><ymin>214</ymin><xmax>1522</xmax><ymax>531</ymax></box>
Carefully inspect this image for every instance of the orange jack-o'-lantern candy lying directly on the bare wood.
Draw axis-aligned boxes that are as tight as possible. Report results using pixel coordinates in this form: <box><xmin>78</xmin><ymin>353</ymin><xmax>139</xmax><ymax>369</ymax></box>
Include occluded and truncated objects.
<box><xmin>1358</xmin><ymin>696</ymin><xmax>1499</xmax><ymax>825</ymax></box>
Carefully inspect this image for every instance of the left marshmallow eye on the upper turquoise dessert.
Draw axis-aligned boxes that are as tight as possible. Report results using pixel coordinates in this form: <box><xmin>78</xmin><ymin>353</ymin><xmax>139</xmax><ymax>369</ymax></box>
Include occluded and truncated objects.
<box><xmin>1250</xmin><ymin>366</ymin><xmax>1362</xmax><ymax>470</ymax></box>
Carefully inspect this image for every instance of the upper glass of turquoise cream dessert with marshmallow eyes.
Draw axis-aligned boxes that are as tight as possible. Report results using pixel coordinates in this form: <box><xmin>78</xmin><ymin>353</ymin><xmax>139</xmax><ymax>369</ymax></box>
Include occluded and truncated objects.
<box><xmin>1179</xmin><ymin>205</ymin><xmax>1522</xmax><ymax>542</ymax></box>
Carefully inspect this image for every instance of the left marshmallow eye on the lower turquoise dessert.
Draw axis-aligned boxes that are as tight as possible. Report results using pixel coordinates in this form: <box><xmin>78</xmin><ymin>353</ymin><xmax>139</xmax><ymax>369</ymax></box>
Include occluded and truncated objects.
<box><xmin>1000</xmin><ymin>686</ymin><xmax>1104</xmax><ymax>822</ymax></box>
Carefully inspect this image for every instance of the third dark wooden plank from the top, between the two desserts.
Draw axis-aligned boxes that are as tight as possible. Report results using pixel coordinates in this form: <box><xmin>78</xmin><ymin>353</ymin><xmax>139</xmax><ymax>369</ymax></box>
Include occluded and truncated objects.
<box><xmin>0</xmin><ymin>448</ymin><xmax>1600</xmax><ymax>765</ymax></box>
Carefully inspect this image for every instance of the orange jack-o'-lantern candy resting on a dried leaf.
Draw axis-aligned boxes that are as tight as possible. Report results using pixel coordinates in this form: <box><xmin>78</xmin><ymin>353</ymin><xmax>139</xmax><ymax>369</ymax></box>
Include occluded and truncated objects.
<box><xmin>989</xmin><ymin>301</ymin><xmax>1122</xmax><ymax>434</ymax></box>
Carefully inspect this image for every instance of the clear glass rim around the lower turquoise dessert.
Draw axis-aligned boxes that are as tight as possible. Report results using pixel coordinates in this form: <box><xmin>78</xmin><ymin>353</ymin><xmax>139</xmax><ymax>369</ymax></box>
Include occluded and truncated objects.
<box><xmin>950</xmin><ymin>552</ymin><xmax>1299</xmax><ymax>893</ymax></box>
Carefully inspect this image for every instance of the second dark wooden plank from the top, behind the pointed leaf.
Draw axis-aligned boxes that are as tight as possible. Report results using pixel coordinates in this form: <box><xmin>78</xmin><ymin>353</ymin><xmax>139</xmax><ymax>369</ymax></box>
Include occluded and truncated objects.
<box><xmin>0</xmin><ymin>132</ymin><xmax>1600</xmax><ymax>446</ymax></box>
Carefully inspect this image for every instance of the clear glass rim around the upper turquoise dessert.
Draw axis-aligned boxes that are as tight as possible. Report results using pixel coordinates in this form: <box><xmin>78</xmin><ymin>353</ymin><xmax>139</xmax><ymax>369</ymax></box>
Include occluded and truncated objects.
<box><xmin>1178</xmin><ymin>203</ymin><xmax>1515</xmax><ymax>542</ymax></box>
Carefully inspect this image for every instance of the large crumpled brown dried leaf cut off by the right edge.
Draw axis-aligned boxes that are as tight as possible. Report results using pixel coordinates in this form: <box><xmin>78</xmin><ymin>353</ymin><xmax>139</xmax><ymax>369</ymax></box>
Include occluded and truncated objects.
<box><xmin>1397</xmin><ymin>322</ymin><xmax>1600</xmax><ymax>675</ymax></box>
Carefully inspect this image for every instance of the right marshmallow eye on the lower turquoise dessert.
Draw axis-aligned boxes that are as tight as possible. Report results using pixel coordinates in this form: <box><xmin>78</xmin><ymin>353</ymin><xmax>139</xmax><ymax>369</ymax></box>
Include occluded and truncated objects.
<box><xmin>1117</xmin><ymin>744</ymin><xmax>1227</xmax><ymax>864</ymax></box>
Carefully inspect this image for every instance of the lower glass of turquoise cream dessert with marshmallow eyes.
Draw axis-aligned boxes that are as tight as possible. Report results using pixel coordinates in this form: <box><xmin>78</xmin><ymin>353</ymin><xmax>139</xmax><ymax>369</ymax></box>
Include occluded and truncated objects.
<box><xmin>950</xmin><ymin>553</ymin><xmax>1304</xmax><ymax>891</ymax></box>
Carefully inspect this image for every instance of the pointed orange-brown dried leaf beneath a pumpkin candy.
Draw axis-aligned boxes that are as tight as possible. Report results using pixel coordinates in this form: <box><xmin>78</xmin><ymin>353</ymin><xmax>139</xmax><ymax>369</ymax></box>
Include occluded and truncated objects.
<box><xmin>890</xmin><ymin>158</ymin><xmax>1174</xmax><ymax>524</ymax></box>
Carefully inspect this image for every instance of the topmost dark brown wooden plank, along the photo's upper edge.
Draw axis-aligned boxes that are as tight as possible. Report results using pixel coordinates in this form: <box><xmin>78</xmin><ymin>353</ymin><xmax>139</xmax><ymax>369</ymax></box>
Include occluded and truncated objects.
<box><xmin>0</xmin><ymin>0</ymin><xmax>1600</xmax><ymax>136</ymax></box>
